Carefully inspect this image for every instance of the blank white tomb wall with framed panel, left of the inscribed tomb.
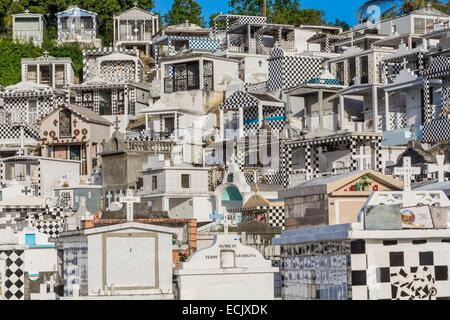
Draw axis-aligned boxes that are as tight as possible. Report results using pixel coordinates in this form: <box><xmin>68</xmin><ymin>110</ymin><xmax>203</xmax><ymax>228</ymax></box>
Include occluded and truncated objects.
<box><xmin>88</xmin><ymin>229</ymin><xmax>172</xmax><ymax>295</ymax></box>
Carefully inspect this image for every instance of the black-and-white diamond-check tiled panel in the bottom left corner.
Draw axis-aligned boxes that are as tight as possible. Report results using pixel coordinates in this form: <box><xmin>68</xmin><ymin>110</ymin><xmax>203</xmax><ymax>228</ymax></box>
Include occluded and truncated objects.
<box><xmin>0</xmin><ymin>249</ymin><xmax>25</xmax><ymax>300</ymax></box>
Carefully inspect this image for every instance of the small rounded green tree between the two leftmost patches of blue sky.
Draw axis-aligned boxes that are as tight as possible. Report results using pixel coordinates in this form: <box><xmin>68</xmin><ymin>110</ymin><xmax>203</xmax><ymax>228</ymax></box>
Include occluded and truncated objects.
<box><xmin>164</xmin><ymin>0</ymin><xmax>205</xmax><ymax>27</ymax></box>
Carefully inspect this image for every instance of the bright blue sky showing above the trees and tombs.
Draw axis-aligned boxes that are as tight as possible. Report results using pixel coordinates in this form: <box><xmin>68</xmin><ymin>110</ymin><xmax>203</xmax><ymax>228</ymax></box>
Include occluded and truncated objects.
<box><xmin>154</xmin><ymin>0</ymin><xmax>364</xmax><ymax>25</ymax></box>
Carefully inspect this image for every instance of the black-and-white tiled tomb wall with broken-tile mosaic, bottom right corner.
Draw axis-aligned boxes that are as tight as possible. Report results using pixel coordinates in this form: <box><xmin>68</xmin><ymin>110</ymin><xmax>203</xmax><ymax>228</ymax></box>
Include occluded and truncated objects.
<box><xmin>351</xmin><ymin>240</ymin><xmax>450</xmax><ymax>300</ymax></box>
